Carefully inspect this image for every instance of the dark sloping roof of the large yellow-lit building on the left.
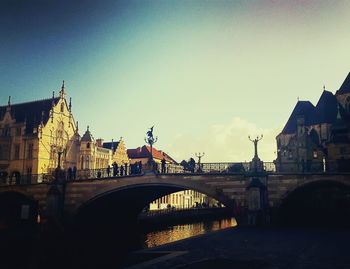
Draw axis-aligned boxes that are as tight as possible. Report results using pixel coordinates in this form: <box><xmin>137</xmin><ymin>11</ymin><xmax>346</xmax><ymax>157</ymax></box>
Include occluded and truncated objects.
<box><xmin>0</xmin><ymin>97</ymin><xmax>60</xmax><ymax>134</ymax></box>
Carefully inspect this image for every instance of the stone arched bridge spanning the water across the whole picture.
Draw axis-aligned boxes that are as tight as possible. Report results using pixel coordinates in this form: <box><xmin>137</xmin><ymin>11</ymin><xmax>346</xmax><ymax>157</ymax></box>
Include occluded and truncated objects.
<box><xmin>0</xmin><ymin>173</ymin><xmax>350</xmax><ymax>225</ymax></box>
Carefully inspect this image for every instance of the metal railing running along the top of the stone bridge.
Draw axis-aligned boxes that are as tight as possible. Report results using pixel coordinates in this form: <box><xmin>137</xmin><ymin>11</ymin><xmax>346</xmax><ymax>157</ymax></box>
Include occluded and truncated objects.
<box><xmin>0</xmin><ymin>160</ymin><xmax>350</xmax><ymax>185</ymax></box>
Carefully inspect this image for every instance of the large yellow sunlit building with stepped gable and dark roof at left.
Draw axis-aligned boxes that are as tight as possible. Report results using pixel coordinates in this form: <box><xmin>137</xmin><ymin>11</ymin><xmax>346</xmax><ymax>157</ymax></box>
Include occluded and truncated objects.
<box><xmin>0</xmin><ymin>82</ymin><xmax>79</xmax><ymax>183</ymax></box>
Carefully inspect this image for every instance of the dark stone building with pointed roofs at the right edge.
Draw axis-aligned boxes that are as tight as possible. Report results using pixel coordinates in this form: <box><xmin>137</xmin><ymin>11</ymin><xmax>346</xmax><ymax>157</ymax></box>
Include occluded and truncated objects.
<box><xmin>275</xmin><ymin>73</ymin><xmax>350</xmax><ymax>172</ymax></box>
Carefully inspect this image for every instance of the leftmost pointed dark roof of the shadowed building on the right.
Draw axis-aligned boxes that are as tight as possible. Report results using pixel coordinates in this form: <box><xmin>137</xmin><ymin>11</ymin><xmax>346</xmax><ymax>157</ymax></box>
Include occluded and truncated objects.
<box><xmin>282</xmin><ymin>101</ymin><xmax>315</xmax><ymax>134</ymax></box>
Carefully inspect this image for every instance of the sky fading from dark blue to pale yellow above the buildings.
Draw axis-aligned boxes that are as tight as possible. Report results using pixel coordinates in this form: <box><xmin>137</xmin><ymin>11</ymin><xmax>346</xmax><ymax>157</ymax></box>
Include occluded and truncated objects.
<box><xmin>0</xmin><ymin>0</ymin><xmax>350</xmax><ymax>162</ymax></box>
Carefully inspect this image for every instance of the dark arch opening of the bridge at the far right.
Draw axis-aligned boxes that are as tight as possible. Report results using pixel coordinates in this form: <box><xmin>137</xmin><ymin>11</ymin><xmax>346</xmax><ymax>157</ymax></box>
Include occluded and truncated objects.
<box><xmin>279</xmin><ymin>179</ymin><xmax>350</xmax><ymax>226</ymax></box>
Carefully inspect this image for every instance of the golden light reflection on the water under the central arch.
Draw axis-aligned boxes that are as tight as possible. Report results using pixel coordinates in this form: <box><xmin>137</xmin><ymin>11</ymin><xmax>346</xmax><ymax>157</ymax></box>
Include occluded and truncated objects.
<box><xmin>142</xmin><ymin>218</ymin><xmax>237</xmax><ymax>248</ymax></box>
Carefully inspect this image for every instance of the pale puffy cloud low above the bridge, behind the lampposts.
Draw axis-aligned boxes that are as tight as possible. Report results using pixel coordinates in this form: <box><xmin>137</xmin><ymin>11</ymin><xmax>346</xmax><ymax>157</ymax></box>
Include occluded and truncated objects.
<box><xmin>168</xmin><ymin>117</ymin><xmax>282</xmax><ymax>162</ymax></box>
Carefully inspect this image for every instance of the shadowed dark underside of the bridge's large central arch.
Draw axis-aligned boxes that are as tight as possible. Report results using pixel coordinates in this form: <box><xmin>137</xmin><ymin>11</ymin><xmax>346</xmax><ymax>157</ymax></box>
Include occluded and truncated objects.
<box><xmin>68</xmin><ymin>177</ymin><xmax>232</xmax><ymax>264</ymax></box>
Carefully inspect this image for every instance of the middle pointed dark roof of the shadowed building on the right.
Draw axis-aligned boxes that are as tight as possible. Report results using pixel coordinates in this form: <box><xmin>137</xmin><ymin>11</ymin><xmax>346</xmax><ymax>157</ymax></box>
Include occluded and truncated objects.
<box><xmin>310</xmin><ymin>90</ymin><xmax>338</xmax><ymax>124</ymax></box>
